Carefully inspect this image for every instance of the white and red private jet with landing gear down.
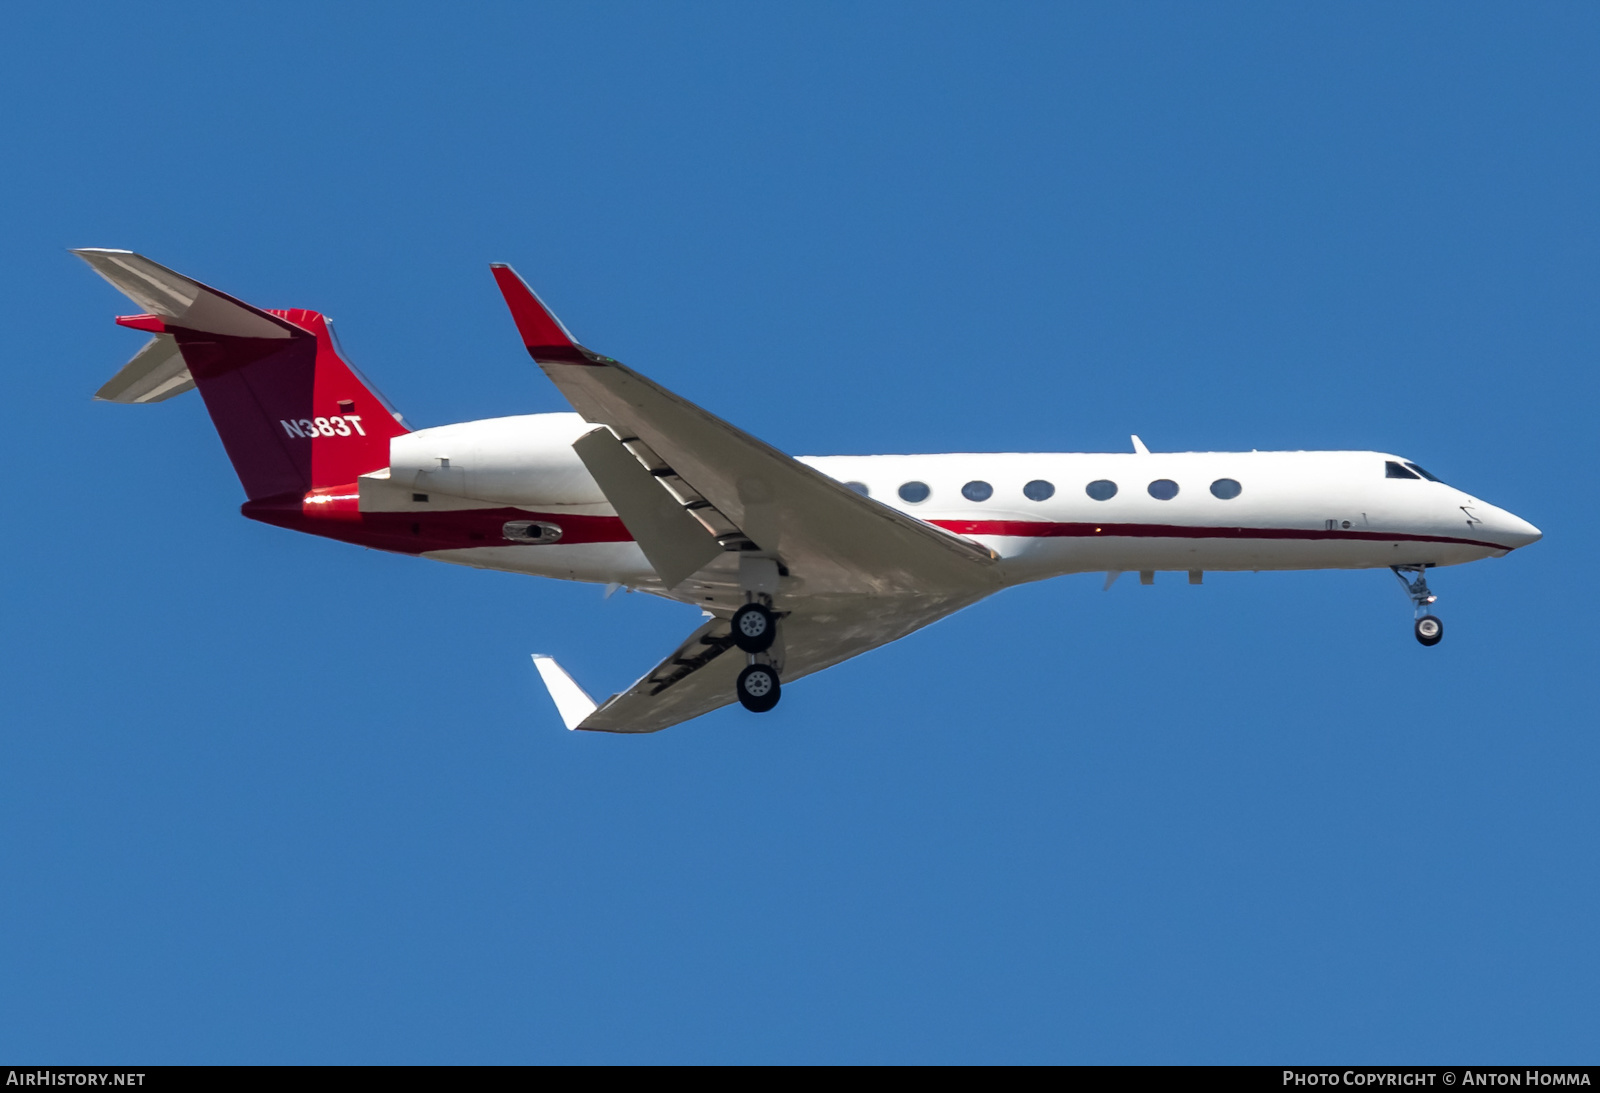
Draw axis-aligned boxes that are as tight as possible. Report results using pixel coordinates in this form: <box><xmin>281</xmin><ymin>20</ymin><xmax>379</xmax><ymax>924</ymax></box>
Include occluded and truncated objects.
<box><xmin>74</xmin><ymin>248</ymin><xmax>1541</xmax><ymax>733</ymax></box>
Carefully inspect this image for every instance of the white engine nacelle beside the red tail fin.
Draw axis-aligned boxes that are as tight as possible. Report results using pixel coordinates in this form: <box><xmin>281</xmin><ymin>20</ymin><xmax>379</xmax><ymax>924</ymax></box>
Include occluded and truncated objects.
<box><xmin>389</xmin><ymin>413</ymin><xmax>605</xmax><ymax>507</ymax></box>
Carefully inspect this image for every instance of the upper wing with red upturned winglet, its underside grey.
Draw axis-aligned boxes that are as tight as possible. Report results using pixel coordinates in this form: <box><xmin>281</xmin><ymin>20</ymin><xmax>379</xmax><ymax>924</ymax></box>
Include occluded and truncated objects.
<box><xmin>493</xmin><ymin>266</ymin><xmax>998</xmax><ymax>598</ymax></box>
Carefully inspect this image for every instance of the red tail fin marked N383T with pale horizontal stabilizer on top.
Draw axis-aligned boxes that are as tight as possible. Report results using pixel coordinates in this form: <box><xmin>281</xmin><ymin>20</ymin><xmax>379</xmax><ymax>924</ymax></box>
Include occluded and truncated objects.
<box><xmin>72</xmin><ymin>248</ymin><xmax>408</xmax><ymax>509</ymax></box>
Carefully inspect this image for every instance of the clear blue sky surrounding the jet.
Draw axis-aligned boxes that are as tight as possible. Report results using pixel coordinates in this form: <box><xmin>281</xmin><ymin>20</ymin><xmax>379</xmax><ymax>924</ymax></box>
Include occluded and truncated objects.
<box><xmin>0</xmin><ymin>3</ymin><xmax>1600</xmax><ymax>1063</ymax></box>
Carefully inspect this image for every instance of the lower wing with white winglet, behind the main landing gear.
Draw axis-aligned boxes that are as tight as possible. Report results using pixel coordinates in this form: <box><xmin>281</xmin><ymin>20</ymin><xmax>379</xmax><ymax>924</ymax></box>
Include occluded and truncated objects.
<box><xmin>539</xmin><ymin>594</ymin><xmax>982</xmax><ymax>733</ymax></box>
